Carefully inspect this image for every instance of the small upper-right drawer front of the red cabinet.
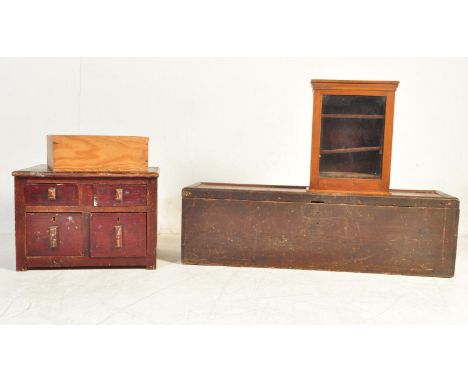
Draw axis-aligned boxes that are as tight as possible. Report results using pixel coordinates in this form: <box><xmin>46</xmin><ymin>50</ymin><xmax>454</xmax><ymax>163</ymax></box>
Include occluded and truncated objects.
<box><xmin>93</xmin><ymin>184</ymin><xmax>146</xmax><ymax>207</ymax></box>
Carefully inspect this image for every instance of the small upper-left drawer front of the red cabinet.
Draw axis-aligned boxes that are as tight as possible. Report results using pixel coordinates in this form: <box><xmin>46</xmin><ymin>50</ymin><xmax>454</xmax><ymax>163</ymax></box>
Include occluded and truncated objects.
<box><xmin>24</xmin><ymin>183</ymin><xmax>78</xmax><ymax>206</ymax></box>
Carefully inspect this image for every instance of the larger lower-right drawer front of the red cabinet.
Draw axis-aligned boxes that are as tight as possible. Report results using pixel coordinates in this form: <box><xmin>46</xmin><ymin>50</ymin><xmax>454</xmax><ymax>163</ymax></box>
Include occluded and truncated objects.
<box><xmin>89</xmin><ymin>213</ymin><xmax>146</xmax><ymax>257</ymax></box>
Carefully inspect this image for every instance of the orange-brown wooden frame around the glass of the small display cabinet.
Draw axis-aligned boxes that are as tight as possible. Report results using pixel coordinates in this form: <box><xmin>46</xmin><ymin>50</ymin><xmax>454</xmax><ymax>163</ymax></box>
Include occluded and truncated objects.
<box><xmin>309</xmin><ymin>80</ymin><xmax>399</xmax><ymax>194</ymax></box>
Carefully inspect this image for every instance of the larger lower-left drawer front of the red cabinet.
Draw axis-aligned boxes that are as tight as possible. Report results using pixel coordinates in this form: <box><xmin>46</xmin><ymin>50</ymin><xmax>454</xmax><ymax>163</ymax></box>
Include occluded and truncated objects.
<box><xmin>26</xmin><ymin>213</ymin><xmax>84</xmax><ymax>256</ymax></box>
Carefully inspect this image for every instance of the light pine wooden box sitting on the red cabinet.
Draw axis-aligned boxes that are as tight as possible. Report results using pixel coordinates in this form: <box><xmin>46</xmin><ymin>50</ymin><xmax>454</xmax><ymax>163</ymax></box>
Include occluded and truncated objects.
<box><xmin>47</xmin><ymin>135</ymin><xmax>149</xmax><ymax>172</ymax></box>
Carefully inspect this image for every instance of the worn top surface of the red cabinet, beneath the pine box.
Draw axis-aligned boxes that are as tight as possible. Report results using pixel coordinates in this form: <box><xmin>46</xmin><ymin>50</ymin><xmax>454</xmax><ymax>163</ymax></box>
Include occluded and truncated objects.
<box><xmin>12</xmin><ymin>164</ymin><xmax>159</xmax><ymax>178</ymax></box>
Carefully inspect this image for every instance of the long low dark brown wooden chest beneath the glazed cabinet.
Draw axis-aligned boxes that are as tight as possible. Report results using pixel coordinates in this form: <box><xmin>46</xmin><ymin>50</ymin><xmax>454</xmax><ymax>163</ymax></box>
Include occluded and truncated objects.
<box><xmin>182</xmin><ymin>183</ymin><xmax>459</xmax><ymax>277</ymax></box>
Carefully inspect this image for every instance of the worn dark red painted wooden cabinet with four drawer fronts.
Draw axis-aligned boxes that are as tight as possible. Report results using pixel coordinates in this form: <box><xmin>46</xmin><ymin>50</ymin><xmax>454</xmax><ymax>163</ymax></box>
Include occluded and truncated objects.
<box><xmin>13</xmin><ymin>165</ymin><xmax>159</xmax><ymax>271</ymax></box>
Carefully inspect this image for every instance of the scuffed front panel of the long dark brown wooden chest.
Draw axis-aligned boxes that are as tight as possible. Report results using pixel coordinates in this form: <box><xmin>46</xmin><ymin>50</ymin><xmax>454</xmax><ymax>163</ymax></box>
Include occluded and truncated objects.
<box><xmin>182</xmin><ymin>198</ymin><xmax>456</xmax><ymax>277</ymax></box>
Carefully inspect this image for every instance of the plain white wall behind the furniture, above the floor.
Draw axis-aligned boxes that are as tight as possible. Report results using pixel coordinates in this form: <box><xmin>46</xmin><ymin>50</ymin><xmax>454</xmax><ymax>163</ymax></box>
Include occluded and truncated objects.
<box><xmin>0</xmin><ymin>58</ymin><xmax>468</xmax><ymax>234</ymax></box>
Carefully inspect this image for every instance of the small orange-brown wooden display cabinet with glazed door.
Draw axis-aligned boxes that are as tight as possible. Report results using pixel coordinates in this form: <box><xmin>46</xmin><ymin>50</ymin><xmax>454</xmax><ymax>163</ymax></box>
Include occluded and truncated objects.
<box><xmin>309</xmin><ymin>80</ymin><xmax>398</xmax><ymax>194</ymax></box>
